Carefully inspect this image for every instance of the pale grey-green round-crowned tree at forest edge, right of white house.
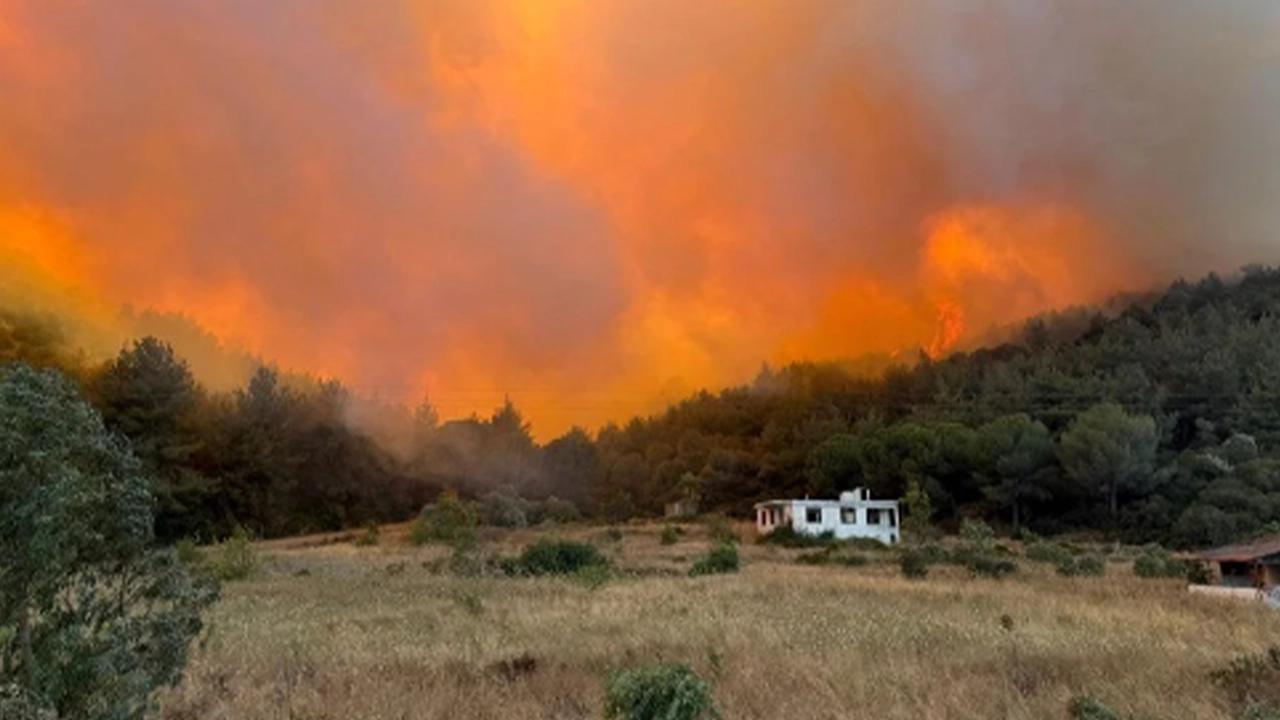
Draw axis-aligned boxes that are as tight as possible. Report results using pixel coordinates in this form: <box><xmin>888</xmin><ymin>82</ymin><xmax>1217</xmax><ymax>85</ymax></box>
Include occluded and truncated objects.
<box><xmin>1057</xmin><ymin>402</ymin><xmax>1160</xmax><ymax>524</ymax></box>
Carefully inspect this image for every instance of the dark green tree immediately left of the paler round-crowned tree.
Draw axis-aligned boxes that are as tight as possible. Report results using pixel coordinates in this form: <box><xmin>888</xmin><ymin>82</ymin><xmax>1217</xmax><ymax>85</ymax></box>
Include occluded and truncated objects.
<box><xmin>978</xmin><ymin>415</ymin><xmax>1055</xmax><ymax>533</ymax></box>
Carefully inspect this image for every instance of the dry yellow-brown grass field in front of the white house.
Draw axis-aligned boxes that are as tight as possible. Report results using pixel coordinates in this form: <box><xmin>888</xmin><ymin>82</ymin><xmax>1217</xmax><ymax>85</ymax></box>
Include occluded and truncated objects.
<box><xmin>163</xmin><ymin>525</ymin><xmax>1280</xmax><ymax>720</ymax></box>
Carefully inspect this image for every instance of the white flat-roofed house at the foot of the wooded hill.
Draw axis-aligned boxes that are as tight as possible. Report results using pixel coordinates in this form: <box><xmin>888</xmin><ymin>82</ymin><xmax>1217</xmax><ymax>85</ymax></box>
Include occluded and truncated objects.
<box><xmin>755</xmin><ymin>488</ymin><xmax>902</xmax><ymax>544</ymax></box>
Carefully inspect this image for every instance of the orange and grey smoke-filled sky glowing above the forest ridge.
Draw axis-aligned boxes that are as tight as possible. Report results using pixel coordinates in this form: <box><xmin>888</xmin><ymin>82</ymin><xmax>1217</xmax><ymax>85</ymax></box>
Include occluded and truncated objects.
<box><xmin>0</xmin><ymin>0</ymin><xmax>1280</xmax><ymax>438</ymax></box>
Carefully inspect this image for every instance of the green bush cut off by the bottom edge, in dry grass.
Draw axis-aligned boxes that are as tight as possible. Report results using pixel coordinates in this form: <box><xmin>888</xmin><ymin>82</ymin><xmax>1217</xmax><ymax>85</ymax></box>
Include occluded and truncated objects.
<box><xmin>604</xmin><ymin>665</ymin><xmax>721</xmax><ymax>720</ymax></box>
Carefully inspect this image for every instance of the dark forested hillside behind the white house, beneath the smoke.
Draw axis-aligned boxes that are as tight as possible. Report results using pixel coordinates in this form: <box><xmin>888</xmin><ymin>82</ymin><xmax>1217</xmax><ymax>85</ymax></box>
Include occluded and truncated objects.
<box><xmin>0</xmin><ymin>268</ymin><xmax>1280</xmax><ymax>546</ymax></box>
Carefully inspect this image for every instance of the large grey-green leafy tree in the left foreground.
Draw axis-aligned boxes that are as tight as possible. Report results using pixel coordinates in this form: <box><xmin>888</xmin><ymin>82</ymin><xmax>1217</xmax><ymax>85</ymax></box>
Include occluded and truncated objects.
<box><xmin>0</xmin><ymin>365</ymin><xmax>216</xmax><ymax>720</ymax></box>
